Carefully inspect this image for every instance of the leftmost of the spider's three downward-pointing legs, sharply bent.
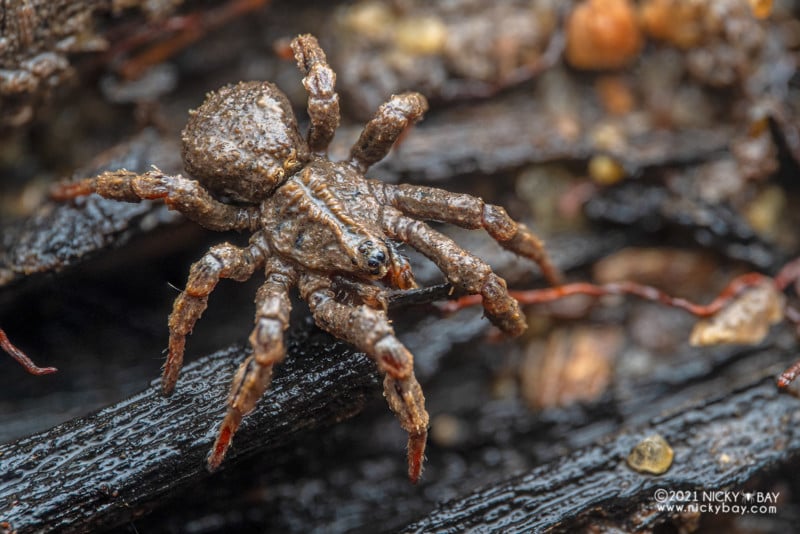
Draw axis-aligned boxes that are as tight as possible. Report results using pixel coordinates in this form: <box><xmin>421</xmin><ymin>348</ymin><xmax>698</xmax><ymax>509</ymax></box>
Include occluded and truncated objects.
<box><xmin>161</xmin><ymin>234</ymin><xmax>267</xmax><ymax>395</ymax></box>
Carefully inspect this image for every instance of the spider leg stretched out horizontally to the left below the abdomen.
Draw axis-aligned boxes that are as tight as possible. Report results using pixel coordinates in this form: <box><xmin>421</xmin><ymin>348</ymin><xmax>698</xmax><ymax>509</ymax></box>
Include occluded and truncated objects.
<box><xmin>50</xmin><ymin>169</ymin><xmax>258</xmax><ymax>232</ymax></box>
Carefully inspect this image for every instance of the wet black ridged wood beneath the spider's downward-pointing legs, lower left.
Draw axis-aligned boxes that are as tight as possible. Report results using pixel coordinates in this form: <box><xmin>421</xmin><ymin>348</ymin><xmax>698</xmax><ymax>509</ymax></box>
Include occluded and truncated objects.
<box><xmin>0</xmin><ymin>332</ymin><xmax>379</xmax><ymax>532</ymax></box>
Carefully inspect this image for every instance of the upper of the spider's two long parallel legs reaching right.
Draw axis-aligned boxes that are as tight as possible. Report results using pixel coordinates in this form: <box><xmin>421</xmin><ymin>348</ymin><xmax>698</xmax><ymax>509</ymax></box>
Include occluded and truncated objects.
<box><xmin>370</xmin><ymin>180</ymin><xmax>563</xmax><ymax>285</ymax></box>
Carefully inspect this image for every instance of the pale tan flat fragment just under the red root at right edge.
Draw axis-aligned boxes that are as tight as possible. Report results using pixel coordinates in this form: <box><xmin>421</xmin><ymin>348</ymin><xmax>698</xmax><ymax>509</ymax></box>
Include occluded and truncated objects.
<box><xmin>689</xmin><ymin>280</ymin><xmax>785</xmax><ymax>346</ymax></box>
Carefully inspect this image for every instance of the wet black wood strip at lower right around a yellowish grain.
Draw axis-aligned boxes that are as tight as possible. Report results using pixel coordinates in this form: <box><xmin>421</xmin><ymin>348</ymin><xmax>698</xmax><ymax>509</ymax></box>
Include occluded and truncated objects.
<box><xmin>404</xmin><ymin>377</ymin><xmax>800</xmax><ymax>533</ymax></box>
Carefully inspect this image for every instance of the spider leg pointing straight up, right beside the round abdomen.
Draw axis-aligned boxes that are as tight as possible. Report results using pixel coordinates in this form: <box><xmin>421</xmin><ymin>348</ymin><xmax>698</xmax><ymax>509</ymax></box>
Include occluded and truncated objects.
<box><xmin>291</xmin><ymin>34</ymin><xmax>340</xmax><ymax>154</ymax></box>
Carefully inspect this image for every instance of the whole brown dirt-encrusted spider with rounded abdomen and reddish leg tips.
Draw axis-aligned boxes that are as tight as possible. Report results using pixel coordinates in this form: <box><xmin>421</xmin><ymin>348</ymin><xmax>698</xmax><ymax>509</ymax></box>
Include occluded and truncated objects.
<box><xmin>52</xmin><ymin>35</ymin><xmax>560</xmax><ymax>482</ymax></box>
